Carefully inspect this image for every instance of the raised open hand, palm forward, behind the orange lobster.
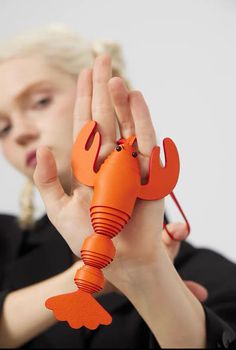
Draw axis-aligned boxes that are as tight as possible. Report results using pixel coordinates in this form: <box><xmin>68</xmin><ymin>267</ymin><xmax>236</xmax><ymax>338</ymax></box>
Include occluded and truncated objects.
<box><xmin>34</xmin><ymin>56</ymin><xmax>206</xmax><ymax>330</ymax></box>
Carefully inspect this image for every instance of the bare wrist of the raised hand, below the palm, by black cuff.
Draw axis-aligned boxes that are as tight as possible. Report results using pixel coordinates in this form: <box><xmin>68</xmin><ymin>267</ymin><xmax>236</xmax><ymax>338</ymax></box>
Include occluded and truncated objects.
<box><xmin>114</xmin><ymin>244</ymin><xmax>206</xmax><ymax>348</ymax></box>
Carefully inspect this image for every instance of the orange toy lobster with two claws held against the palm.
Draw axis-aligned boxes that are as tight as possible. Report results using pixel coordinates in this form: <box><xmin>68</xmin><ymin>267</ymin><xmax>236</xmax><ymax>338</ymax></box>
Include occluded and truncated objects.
<box><xmin>46</xmin><ymin>121</ymin><xmax>179</xmax><ymax>329</ymax></box>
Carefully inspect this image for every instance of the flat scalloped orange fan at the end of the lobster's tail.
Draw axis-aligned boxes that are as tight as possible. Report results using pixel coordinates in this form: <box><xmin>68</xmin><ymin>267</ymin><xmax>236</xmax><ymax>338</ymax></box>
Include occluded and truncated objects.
<box><xmin>45</xmin><ymin>290</ymin><xmax>112</xmax><ymax>330</ymax></box>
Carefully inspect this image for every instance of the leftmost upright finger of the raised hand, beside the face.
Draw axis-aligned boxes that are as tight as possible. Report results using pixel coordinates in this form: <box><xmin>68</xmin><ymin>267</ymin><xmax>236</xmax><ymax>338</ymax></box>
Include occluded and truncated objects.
<box><xmin>73</xmin><ymin>68</ymin><xmax>93</xmax><ymax>141</ymax></box>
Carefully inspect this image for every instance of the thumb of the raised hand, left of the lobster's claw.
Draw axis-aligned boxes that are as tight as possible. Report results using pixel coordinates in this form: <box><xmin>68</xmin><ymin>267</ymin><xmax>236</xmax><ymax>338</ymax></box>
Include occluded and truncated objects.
<box><xmin>33</xmin><ymin>146</ymin><xmax>68</xmax><ymax>217</ymax></box>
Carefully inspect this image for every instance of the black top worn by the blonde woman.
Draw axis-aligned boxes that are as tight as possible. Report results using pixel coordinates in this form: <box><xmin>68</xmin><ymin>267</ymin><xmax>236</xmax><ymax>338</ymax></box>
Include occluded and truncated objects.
<box><xmin>0</xmin><ymin>215</ymin><xmax>236</xmax><ymax>349</ymax></box>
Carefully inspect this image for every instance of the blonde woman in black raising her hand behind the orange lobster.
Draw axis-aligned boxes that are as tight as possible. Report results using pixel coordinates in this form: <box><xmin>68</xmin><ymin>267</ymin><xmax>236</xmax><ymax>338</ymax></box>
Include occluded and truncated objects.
<box><xmin>0</xmin><ymin>26</ymin><xmax>235</xmax><ymax>348</ymax></box>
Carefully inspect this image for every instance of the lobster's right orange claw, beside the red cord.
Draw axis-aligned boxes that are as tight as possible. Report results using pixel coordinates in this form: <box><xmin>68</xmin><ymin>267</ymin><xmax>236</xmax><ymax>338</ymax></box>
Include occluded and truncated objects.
<box><xmin>138</xmin><ymin>138</ymin><xmax>180</xmax><ymax>200</ymax></box>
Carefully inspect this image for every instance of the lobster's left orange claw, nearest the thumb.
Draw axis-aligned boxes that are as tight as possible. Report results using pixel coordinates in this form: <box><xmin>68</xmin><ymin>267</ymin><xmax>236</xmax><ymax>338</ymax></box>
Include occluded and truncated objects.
<box><xmin>71</xmin><ymin>120</ymin><xmax>101</xmax><ymax>187</ymax></box>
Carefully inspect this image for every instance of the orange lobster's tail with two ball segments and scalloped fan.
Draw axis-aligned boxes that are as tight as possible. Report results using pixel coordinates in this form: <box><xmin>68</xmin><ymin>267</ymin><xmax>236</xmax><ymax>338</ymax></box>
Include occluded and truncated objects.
<box><xmin>45</xmin><ymin>233</ymin><xmax>115</xmax><ymax>329</ymax></box>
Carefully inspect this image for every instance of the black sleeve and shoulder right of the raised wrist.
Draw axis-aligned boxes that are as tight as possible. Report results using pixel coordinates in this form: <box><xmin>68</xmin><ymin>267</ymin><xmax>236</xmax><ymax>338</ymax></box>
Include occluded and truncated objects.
<box><xmin>149</xmin><ymin>242</ymin><xmax>236</xmax><ymax>349</ymax></box>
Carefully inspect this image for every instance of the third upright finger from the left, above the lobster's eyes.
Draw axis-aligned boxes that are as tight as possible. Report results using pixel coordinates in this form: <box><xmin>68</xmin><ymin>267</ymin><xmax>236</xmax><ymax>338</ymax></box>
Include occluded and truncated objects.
<box><xmin>108</xmin><ymin>77</ymin><xmax>135</xmax><ymax>139</ymax></box>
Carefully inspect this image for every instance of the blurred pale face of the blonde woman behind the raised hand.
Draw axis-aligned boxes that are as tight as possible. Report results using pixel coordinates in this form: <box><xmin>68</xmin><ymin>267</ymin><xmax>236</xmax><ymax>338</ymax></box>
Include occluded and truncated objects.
<box><xmin>0</xmin><ymin>56</ymin><xmax>76</xmax><ymax>193</ymax></box>
